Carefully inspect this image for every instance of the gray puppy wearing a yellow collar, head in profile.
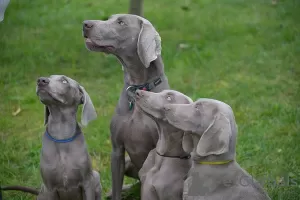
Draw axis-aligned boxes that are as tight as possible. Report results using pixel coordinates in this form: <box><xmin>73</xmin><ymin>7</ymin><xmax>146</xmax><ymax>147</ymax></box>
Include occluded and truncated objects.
<box><xmin>158</xmin><ymin>96</ymin><xmax>270</xmax><ymax>200</ymax></box>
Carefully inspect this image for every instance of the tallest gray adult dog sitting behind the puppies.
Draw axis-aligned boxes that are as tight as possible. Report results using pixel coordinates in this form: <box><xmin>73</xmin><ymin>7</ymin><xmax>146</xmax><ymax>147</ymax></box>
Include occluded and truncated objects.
<box><xmin>83</xmin><ymin>14</ymin><xmax>169</xmax><ymax>200</ymax></box>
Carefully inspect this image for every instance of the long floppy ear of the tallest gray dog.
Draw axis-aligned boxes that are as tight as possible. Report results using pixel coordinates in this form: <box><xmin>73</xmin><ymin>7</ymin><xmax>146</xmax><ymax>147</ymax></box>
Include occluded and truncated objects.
<box><xmin>137</xmin><ymin>18</ymin><xmax>161</xmax><ymax>68</ymax></box>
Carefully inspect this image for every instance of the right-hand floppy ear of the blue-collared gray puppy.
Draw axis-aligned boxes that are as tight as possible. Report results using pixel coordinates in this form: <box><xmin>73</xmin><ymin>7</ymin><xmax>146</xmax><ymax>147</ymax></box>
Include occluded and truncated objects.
<box><xmin>80</xmin><ymin>86</ymin><xmax>97</xmax><ymax>126</ymax></box>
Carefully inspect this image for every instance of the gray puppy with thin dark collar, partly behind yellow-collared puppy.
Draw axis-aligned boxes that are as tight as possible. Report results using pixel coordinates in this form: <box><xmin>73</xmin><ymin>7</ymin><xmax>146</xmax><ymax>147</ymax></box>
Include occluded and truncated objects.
<box><xmin>136</xmin><ymin>90</ymin><xmax>193</xmax><ymax>200</ymax></box>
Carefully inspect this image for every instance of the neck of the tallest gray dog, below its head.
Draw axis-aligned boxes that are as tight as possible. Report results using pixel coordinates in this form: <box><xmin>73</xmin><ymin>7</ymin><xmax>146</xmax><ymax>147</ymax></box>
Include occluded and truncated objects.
<box><xmin>117</xmin><ymin>52</ymin><xmax>164</xmax><ymax>85</ymax></box>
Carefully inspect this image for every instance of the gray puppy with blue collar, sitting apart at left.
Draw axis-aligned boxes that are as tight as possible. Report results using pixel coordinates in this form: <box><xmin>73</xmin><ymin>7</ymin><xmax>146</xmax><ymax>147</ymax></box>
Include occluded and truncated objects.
<box><xmin>36</xmin><ymin>75</ymin><xmax>101</xmax><ymax>200</ymax></box>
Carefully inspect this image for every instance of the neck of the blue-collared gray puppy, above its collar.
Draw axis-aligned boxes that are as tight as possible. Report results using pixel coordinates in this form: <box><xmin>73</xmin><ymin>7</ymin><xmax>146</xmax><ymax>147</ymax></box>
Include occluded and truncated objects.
<box><xmin>46</xmin><ymin>106</ymin><xmax>79</xmax><ymax>140</ymax></box>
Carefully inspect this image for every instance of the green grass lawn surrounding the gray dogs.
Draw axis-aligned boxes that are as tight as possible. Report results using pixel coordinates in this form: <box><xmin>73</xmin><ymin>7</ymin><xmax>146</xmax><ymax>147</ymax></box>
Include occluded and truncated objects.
<box><xmin>0</xmin><ymin>0</ymin><xmax>300</xmax><ymax>200</ymax></box>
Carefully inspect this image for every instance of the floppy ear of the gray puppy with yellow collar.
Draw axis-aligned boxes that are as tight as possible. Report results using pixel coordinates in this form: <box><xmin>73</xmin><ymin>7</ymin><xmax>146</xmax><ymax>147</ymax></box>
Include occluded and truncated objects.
<box><xmin>196</xmin><ymin>113</ymin><xmax>231</xmax><ymax>156</ymax></box>
